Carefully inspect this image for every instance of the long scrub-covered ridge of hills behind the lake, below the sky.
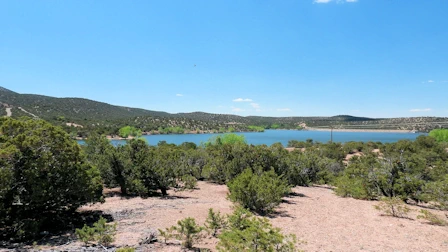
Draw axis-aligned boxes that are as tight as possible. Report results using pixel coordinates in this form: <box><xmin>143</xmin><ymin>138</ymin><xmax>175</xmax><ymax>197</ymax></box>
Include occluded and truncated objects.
<box><xmin>0</xmin><ymin>87</ymin><xmax>448</xmax><ymax>135</ymax></box>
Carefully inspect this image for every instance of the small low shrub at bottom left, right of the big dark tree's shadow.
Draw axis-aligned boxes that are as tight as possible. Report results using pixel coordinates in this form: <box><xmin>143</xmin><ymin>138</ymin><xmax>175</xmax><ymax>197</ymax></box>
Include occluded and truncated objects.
<box><xmin>75</xmin><ymin>217</ymin><xmax>117</xmax><ymax>246</ymax></box>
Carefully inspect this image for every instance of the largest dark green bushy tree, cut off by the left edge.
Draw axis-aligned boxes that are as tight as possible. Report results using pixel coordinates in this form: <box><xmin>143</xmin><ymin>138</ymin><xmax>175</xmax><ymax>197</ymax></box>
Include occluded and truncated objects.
<box><xmin>0</xmin><ymin>118</ymin><xmax>102</xmax><ymax>238</ymax></box>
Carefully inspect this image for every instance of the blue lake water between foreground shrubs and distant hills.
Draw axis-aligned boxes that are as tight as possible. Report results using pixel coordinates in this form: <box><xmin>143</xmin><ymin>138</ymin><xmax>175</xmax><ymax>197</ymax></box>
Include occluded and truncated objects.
<box><xmin>79</xmin><ymin>130</ymin><xmax>425</xmax><ymax>146</ymax></box>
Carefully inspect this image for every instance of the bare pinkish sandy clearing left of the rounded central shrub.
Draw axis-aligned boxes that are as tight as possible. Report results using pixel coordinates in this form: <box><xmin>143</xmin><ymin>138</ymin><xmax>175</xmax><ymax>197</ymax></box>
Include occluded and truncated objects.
<box><xmin>81</xmin><ymin>182</ymin><xmax>232</xmax><ymax>251</ymax></box>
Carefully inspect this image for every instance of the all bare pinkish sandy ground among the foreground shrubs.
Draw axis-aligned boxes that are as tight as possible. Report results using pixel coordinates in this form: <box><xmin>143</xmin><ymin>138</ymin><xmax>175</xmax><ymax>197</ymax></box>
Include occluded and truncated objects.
<box><xmin>13</xmin><ymin>182</ymin><xmax>448</xmax><ymax>252</ymax></box>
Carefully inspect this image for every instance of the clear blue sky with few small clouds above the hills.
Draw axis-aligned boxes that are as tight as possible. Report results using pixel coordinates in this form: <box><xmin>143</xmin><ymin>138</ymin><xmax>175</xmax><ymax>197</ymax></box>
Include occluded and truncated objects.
<box><xmin>0</xmin><ymin>0</ymin><xmax>448</xmax><ymax>117</ymax></box>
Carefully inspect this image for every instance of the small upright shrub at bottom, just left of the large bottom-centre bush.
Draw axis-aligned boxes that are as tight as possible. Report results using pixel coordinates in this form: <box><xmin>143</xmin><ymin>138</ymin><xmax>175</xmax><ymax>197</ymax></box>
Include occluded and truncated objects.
<box><xmin>173</xmin><ymin>217</ymin><xmax>203</xmax><ymax>249</ymax></box>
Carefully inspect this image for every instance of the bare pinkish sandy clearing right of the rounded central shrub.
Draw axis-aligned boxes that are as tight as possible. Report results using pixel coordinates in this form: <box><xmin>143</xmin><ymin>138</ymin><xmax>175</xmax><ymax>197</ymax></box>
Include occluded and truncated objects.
<box><xmin>272</xmin><ymin>187</ymin><xmax>448</xmax><ymax>251</ymax></box>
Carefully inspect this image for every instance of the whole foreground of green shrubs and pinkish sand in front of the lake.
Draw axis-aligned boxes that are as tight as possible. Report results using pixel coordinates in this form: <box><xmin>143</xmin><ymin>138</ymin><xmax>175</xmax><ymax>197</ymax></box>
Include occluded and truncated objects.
<box><xmin>0</xmin><ymin>118</ymin><xmax>448</xmax><ymax>251</ymax></box>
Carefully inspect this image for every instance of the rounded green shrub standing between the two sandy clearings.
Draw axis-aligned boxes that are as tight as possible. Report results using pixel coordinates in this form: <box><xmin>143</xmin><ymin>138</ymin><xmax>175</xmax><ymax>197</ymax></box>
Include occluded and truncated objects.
<box><xmin>228</xmin><ymin>169</ymin><xmax>291</xmax><ymax>214</ymax></box>
